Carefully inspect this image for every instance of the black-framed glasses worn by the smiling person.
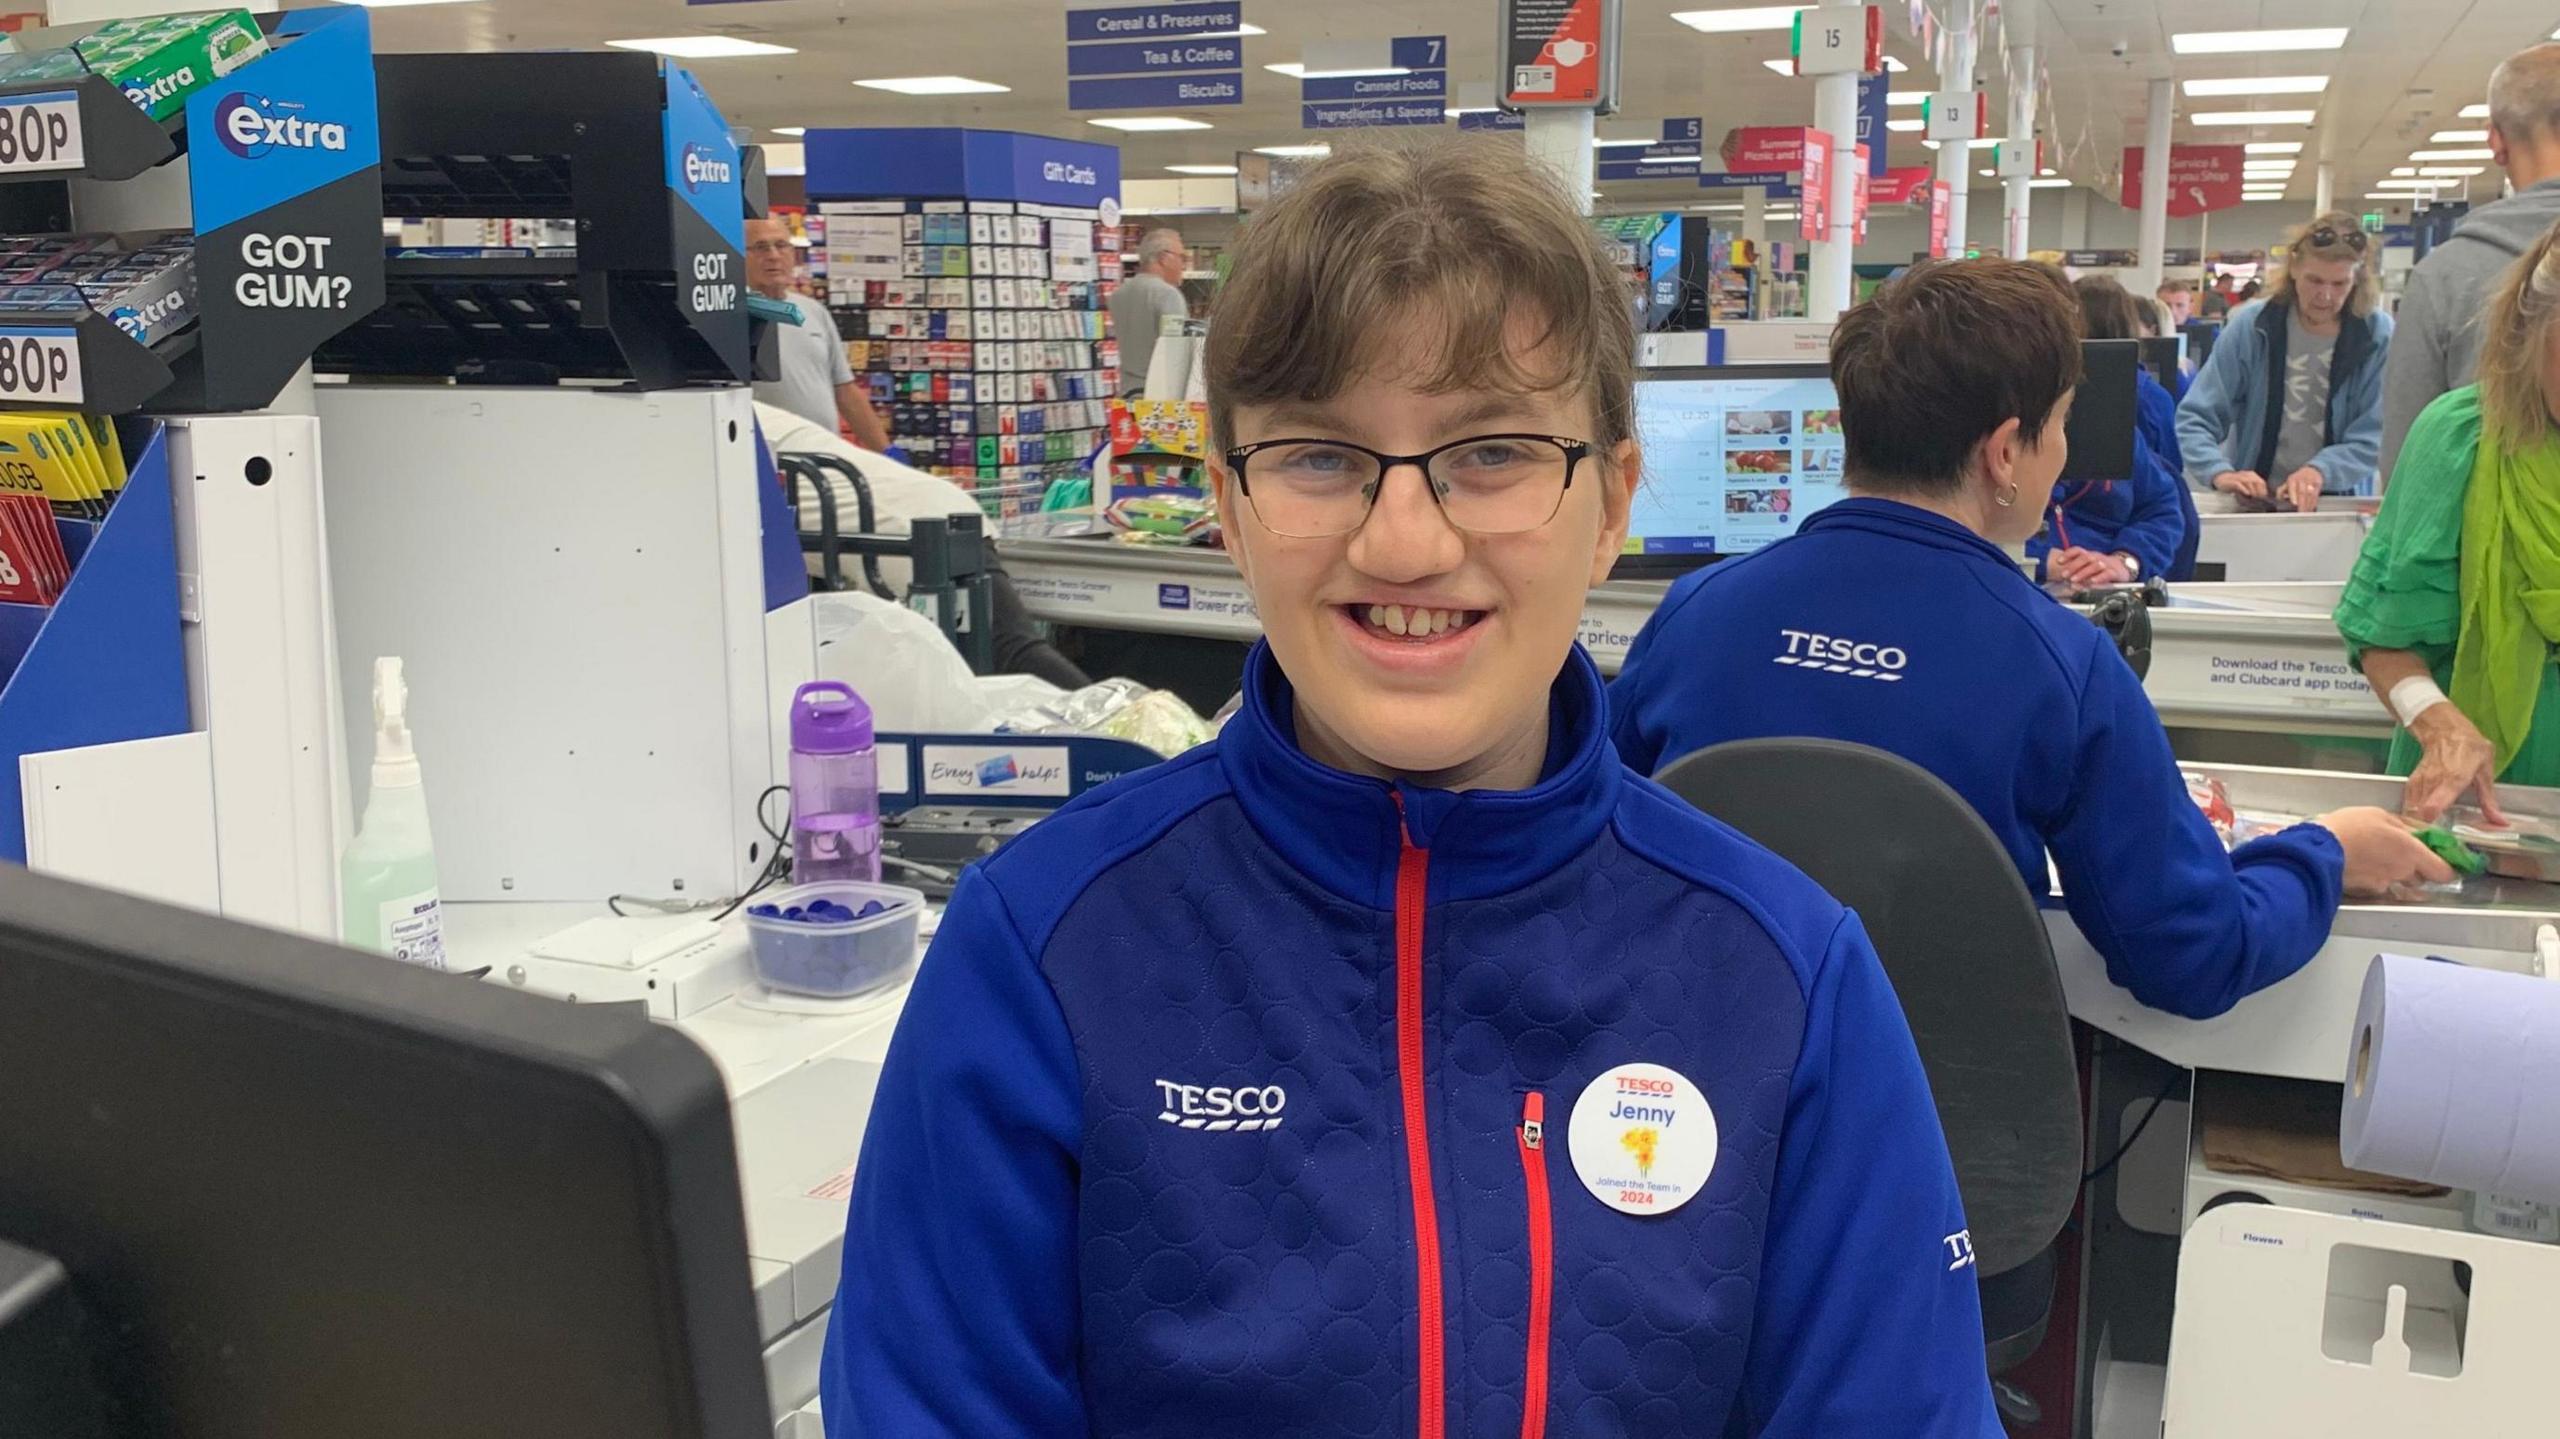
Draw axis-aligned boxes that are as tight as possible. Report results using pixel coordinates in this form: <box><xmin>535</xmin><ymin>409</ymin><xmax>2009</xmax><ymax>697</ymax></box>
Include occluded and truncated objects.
<box><xmin>1226</xmin><ymin>435</ymin><xmax>1592</xmax><ymax>540</ymax></box>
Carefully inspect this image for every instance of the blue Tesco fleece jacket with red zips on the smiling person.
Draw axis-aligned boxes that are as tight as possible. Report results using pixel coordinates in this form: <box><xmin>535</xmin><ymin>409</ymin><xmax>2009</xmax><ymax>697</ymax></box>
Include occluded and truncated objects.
<box><xmin>822</xmin><ymin>648</ymin><xmax>1999</xmax><ymax>1439</ymax></box>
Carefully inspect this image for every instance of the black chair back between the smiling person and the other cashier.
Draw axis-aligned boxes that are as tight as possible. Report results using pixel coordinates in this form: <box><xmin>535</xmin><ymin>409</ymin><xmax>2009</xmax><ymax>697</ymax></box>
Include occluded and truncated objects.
<box><xmin>1659</xmin><ymin>740</ymin><xmax>2081</xmax><ymax>1421</ymax></box>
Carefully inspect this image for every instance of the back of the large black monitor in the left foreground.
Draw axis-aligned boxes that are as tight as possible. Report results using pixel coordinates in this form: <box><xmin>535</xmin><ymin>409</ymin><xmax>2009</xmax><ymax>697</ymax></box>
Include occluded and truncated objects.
<box><xmin>0</xmin><ymin>865</ymin><xmax>762</xmax><ymax>1439</ymax></box>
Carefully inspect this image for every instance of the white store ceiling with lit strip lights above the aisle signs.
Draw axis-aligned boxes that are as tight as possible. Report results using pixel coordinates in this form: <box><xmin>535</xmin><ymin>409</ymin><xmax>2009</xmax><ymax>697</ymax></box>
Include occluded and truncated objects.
<box><xmin>340</xmin><ymin>0</ymin><xmax>2560</xmax><ymax>207</ymax></box>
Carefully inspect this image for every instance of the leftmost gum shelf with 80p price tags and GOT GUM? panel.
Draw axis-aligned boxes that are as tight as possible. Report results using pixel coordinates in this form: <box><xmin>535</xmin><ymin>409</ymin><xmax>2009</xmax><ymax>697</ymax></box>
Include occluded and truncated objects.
<box><xmin>0</xmin><ymin>8</ymin><xmax>381</xmax><ymax>415</ymax></box>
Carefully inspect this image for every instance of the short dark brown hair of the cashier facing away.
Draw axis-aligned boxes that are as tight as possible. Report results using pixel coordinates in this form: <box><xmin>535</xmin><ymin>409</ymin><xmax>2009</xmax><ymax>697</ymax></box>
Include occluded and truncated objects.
<box><xmin>1830</xmin><ymin>259</ymin><xmax>2081</xmax><ymax>494</ymax></box>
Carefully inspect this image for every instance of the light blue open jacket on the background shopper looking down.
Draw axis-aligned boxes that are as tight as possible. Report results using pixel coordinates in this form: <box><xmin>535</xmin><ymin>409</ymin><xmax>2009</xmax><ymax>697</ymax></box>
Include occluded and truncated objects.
<box><xmin>2179</xmin><ymin>300</ymin><xmax>2391</xmax><ymax>494</ymax></box>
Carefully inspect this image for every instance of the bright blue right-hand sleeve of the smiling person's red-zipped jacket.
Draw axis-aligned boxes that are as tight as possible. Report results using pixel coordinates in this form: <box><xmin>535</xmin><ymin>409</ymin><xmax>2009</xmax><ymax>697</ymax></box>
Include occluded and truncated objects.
<box><xmin>1728</xmin><ymin>914</ymin><xmax>2002</xmax><ymax>1439</ymax></box>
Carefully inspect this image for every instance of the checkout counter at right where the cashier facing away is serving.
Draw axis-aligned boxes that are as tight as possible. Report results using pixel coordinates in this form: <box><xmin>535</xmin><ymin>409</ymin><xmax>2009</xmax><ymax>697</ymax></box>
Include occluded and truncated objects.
<box><xmin>2048</xmin><ymin>763</ymin><xmax>2560</xmax><ymax>1436</ymax></box>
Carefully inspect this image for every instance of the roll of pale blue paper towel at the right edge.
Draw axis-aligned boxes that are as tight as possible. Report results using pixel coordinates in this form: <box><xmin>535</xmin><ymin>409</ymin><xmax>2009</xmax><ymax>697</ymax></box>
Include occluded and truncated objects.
<box><xmin>2337</xmin><ymin>955</ymin><xmax>2560</xmax><ymax>1203</ymax></box>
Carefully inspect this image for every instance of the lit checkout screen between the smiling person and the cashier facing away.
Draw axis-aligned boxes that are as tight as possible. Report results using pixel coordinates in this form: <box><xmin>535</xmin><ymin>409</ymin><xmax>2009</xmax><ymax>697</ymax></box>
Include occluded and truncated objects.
<box><xmin>1626</xmin><ymin>369</ymin><xmax>1848</xmax><ymax>556</ymax></box>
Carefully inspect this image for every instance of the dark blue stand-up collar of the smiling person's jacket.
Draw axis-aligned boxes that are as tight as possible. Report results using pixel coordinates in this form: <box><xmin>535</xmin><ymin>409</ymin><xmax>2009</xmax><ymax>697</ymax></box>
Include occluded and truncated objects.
<box><xmin>1219</xmin><ymin>643</ymin><xmax>1623</xmax><ymax>909</ymax></box>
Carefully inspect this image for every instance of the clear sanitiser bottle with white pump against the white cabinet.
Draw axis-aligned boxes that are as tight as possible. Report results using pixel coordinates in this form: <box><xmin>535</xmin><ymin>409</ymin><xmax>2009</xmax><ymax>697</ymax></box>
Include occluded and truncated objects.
<box><xmin>338</xmin><ymin>655</ymin><xmax>445</xmax><ymax>970</ymax></box>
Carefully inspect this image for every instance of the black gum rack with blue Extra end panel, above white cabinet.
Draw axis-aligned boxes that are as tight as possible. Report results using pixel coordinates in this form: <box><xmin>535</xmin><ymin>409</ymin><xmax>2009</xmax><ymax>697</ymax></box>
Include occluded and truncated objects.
<box><xmin>315</xmin><ymin>54</ymin><xmax>760</xmax><ymax>389</ymax></box>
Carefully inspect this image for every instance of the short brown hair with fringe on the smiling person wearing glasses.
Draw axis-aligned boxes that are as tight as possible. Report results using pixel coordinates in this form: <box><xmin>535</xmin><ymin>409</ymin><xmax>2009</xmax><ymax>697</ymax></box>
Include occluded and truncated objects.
<box><xmin>1208</xmin><ymin>136</ymin><xmax>1636</xmax><ymax>456</ymax></box>
